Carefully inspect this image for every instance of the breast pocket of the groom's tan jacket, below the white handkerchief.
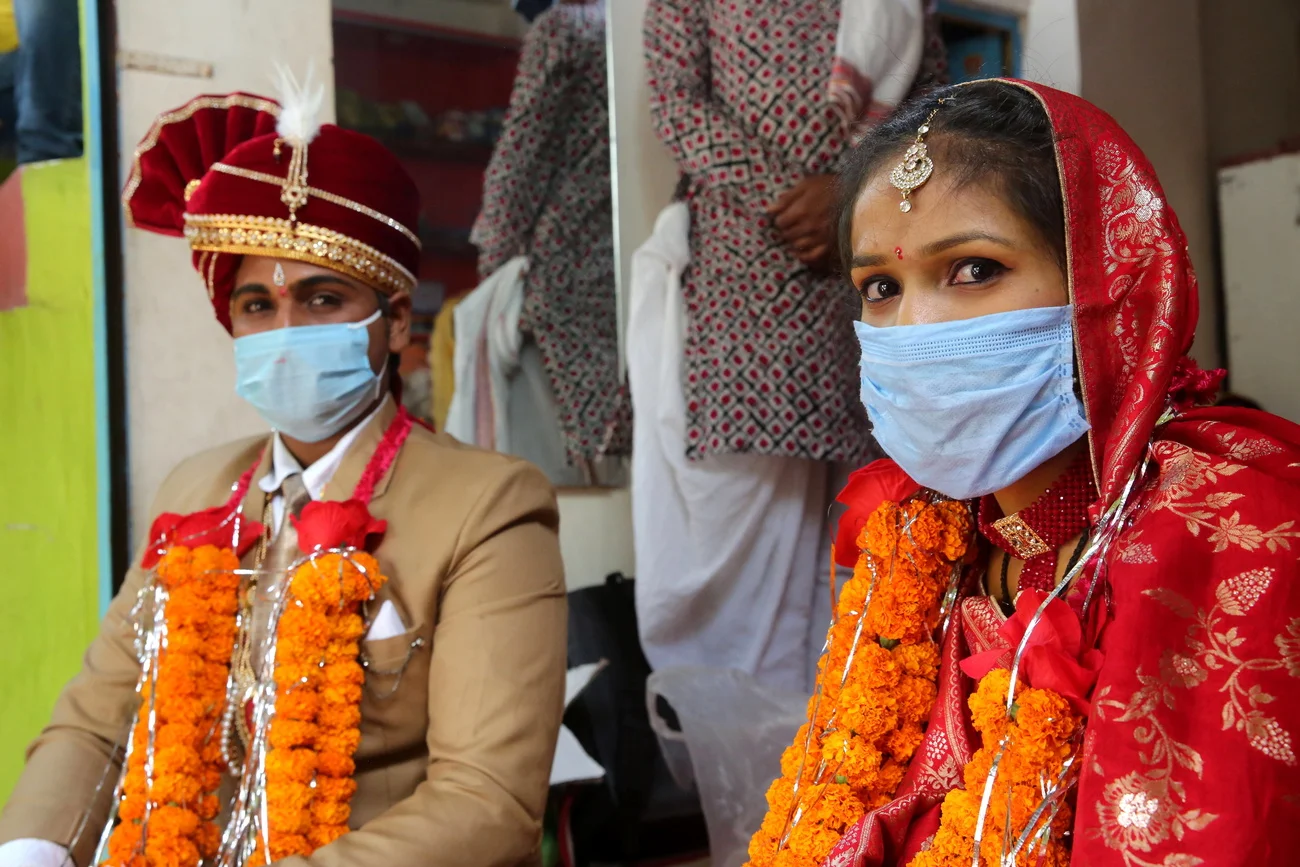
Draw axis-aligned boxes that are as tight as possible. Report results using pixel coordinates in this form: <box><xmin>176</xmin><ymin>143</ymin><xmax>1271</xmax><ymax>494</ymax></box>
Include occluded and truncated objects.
<box><xmin>361</xmin><ymin>627</ymin><xmax>432</xmax><ymax>744</ymax></box>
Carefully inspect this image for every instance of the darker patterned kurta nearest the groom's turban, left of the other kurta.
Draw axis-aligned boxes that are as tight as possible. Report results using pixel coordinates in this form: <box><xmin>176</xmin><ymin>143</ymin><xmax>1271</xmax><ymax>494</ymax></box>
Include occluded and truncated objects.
<box><xmin>471</xmin><ymin>0</ymin><xmax>631</xmax><ymax>463</ymax></box>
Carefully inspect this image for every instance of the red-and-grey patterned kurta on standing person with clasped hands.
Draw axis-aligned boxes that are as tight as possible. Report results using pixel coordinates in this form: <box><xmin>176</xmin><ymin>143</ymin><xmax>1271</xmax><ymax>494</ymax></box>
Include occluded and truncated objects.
<box><xmin>645</xmin><ymin>0</ymin><xmax>941</xmax><ymax>461</ymax></box>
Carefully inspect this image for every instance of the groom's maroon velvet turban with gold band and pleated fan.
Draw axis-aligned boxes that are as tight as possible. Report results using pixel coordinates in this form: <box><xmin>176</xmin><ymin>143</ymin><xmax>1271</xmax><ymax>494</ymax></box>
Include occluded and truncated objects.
<box><xmin>122</xmin><ymin>94</ymin><xmax>420</xmax><ymax>329</ymax></box>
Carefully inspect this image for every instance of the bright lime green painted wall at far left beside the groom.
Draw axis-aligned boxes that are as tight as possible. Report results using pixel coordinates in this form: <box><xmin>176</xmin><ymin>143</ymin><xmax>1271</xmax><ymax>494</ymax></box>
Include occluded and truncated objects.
<box><xmin>0</xmin><ymin>159</ymin><xmax>99</xmax><ymax>802</ymax></box>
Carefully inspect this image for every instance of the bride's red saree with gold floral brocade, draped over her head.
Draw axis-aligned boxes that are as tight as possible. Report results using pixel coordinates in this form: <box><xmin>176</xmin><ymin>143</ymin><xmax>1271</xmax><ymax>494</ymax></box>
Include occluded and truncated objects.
<box><xmin>827</xmin><ymin>82</ymin><xmax>1300</xmax><ymax>867</ymax></box>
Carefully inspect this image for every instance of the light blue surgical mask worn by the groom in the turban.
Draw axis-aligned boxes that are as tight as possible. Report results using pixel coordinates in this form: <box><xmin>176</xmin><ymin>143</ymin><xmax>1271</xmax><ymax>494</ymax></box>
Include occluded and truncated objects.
<box><xmin>235</xmin><ymin>311</ymin><xmax>387</xmax><ymax>442</ymax></box>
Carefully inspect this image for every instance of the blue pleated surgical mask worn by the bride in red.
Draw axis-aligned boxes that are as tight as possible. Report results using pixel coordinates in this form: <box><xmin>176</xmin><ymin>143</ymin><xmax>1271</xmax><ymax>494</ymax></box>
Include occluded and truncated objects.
<box><xmin>854</xmin><ymin>307</ymin><xmax>1088</xmax><ymax>499</ymax></box>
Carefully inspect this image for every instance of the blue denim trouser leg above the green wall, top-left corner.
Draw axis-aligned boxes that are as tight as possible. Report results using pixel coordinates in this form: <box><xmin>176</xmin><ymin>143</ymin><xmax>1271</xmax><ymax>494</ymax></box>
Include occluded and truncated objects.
<box><xmin>13</xmin><ymin>0</ymin><xmax>82</xmax><ymax>162</ymax></box>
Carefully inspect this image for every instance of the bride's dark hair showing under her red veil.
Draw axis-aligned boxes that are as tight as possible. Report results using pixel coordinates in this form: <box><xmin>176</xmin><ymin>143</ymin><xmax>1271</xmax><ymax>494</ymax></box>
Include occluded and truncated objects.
<box><xmin>836</xmin><ymin>81</ymin><xmax>1066</xmax><ymax>273</ymax></box>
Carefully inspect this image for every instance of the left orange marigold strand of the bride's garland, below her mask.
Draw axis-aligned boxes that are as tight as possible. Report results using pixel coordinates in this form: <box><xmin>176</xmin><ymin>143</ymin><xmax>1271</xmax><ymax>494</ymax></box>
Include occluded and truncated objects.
<box><xmin>749</xmin><ymin>498</ymin><xmax>971</xmax><ymax>867</ymax></box>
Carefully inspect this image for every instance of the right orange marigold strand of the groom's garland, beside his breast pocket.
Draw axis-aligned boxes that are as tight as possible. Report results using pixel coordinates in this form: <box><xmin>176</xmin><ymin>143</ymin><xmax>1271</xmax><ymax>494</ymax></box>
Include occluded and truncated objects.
<box><xmin>247</xmin><ymin>551</ymin><xmax>385</xmax><ymax>867</ymax></box>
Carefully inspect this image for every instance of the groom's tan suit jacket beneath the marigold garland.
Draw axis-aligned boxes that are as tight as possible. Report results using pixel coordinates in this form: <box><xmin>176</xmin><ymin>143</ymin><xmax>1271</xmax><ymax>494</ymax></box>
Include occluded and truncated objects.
<box><xmin>0</xmin><ymin>402</ymin><xmax>567</xmax><ymax>867</ymax></box>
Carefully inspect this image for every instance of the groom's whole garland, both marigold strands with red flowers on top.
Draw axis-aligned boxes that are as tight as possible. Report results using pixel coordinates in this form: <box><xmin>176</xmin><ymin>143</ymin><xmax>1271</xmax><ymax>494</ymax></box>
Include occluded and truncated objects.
<box><xmin>100</xmin><ymin>408</ymin><xmax>413</xmax><ymax>867</ymax></box>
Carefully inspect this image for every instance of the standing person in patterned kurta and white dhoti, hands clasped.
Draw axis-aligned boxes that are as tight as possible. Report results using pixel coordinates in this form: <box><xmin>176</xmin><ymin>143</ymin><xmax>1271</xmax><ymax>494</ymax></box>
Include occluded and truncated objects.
<box><xmin>628</xmin><ymin>0</ymin><xmax>944</xmax><ymax>690</ymax></box>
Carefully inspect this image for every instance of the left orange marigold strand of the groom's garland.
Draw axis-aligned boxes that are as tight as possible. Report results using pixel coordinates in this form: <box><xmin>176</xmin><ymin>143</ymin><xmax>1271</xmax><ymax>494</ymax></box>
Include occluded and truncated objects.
<box><xmin>104</xmin><ymin>545</ymin><xmax>239</xmax><ymax>867</ymax></box>
